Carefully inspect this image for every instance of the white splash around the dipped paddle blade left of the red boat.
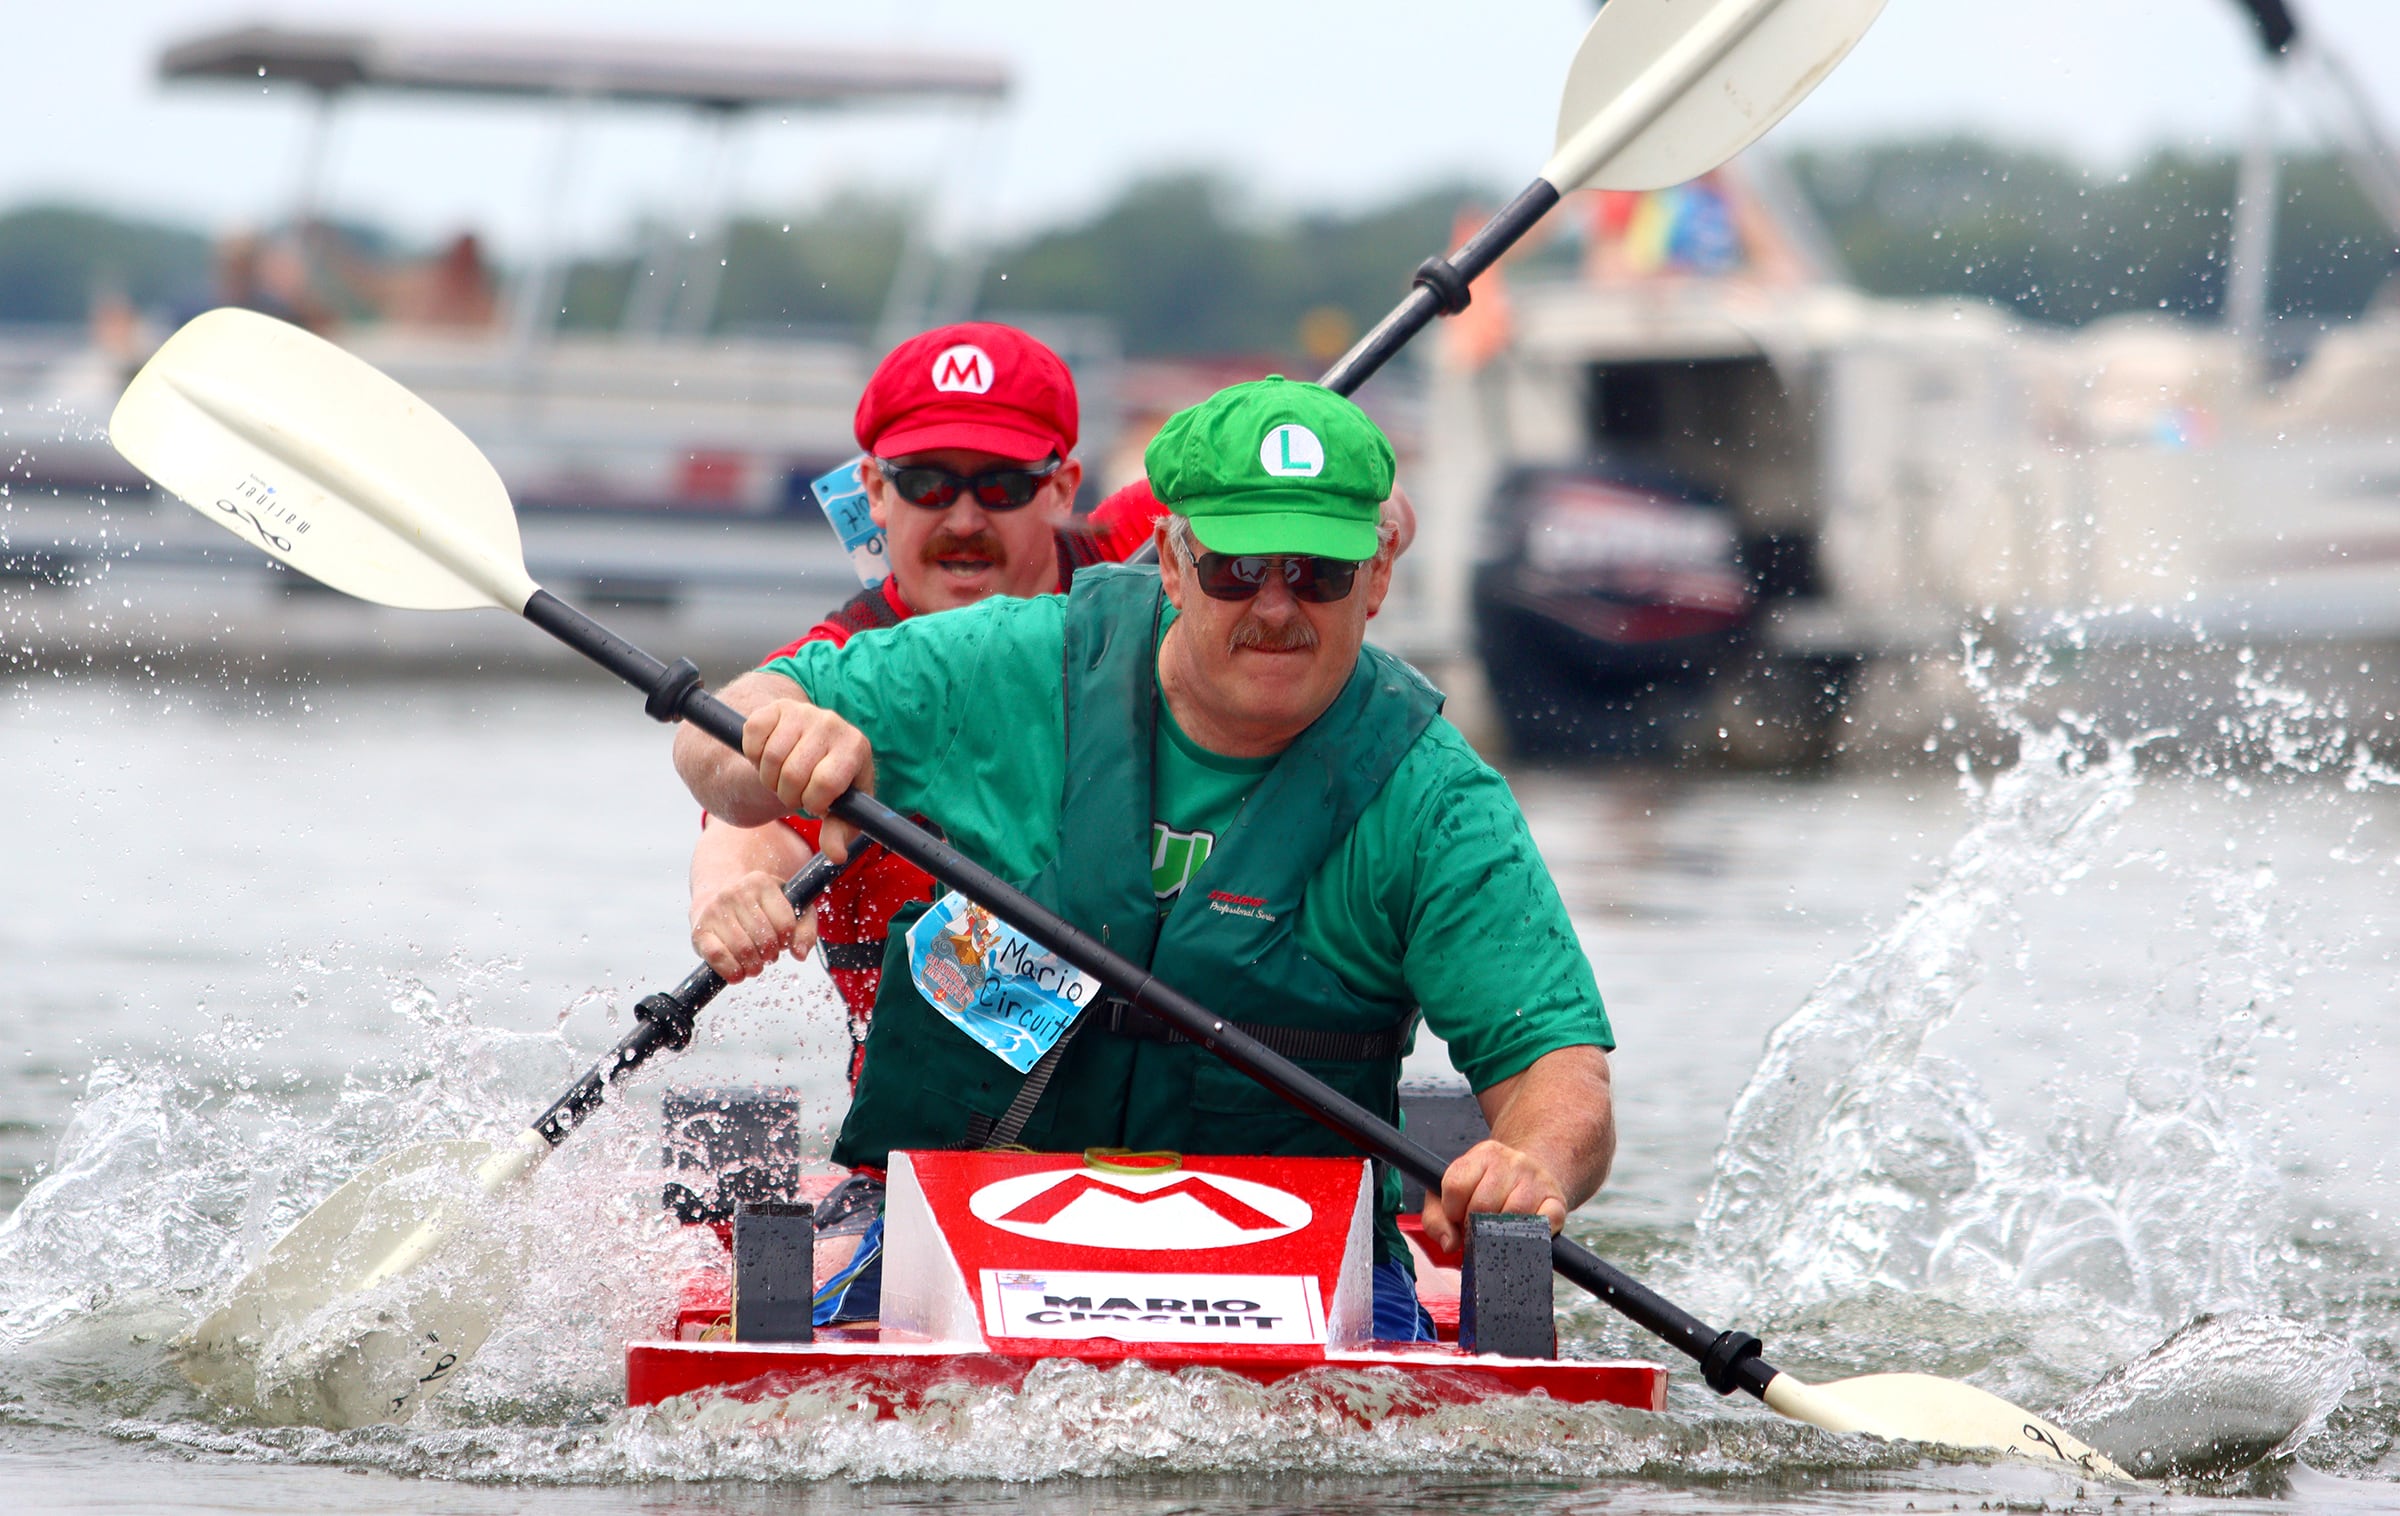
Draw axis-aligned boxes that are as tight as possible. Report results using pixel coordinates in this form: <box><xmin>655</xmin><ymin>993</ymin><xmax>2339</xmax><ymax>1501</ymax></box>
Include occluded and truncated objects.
<box><xmin>0</xmin><ymin>964</ymin><xmax>686</xmax><ymax>1427</ymax></box>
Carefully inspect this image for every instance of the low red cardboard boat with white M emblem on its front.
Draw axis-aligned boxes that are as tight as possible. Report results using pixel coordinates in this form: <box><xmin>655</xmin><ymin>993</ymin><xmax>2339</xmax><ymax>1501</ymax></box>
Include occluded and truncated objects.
<box><xmin>626</xmin><ymin>1151</ymin><xmax>1666</xmax><ymax>1415</ymax></box>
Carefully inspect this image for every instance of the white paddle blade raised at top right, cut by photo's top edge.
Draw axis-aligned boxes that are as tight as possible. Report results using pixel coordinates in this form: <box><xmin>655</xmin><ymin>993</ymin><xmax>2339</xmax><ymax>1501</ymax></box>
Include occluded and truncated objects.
<box><xmin>1541</xmin><ymin>0</ymin><xmax>1884</xmax><ymax>192</ymax></box>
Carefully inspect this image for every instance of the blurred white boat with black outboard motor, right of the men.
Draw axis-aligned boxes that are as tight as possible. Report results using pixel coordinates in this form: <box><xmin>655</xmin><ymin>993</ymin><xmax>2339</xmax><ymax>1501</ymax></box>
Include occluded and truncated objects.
<box><xmin>1411</xmin><ymin>0</ymin><xmax>2400</xmax><ymax>765</ymax></box>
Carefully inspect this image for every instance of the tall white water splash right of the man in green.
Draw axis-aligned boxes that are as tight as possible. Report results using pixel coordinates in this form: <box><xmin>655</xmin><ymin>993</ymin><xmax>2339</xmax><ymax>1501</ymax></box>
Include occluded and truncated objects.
<box><xmin>1699</xmin><ymin>700</ymin><xmax>2188</xmax><ymax>1305</ymax></box>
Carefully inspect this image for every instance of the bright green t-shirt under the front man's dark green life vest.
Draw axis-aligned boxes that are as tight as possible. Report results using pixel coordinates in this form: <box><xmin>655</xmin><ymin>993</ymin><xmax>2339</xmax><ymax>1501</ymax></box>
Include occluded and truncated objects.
<box><xmin>766</xmin><ymin>595</ymin><xmax>1615</xmax><ymax>1089</ymax></box>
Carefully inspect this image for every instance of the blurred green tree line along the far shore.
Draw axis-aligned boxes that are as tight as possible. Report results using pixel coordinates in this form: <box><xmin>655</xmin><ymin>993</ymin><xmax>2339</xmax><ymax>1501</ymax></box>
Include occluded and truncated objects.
<box><xmin>0</xmin><ymin>137</ymin><xmax>2393</xmax><ymax>355</ymax></box>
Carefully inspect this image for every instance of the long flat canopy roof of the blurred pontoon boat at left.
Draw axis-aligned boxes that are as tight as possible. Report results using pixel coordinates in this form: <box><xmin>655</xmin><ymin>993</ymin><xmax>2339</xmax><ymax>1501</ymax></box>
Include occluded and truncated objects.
<box><xmin>158</xmin><ymin>26</ymin><xmax>1008</xmax><ymax>110</ymax></box>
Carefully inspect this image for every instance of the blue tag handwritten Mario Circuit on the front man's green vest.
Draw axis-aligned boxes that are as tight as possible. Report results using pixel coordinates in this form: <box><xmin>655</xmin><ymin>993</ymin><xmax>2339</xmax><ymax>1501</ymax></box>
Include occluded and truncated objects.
<box><xmin>907</xmin><ymin>890</ymin><xmax>1099</xmax><ymax>1075</ymax></box>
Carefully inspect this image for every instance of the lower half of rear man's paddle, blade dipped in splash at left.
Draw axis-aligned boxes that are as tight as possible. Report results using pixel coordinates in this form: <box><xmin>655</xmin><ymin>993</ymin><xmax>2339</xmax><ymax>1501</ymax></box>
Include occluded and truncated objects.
<box><xmin>171</xmin><ymin>829</ymin><xmax>842</xmax><ymax>1427</ymax></box>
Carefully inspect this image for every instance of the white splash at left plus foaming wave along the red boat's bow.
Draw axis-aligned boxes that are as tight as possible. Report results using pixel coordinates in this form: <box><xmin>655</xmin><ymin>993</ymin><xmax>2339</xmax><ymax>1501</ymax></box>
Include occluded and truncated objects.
<box><xmin>0</xmin><ymin>940</ymin><xmax>1889</xmax><ymax>1485</ymax></box>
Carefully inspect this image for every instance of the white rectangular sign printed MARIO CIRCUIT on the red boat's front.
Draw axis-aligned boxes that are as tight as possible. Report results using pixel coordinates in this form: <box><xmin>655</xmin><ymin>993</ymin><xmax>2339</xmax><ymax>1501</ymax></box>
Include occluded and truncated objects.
<box><xmin>984</xmin><ymin>1269</ymin><xmax>1325</xmax><ymax>1343</ymax></box>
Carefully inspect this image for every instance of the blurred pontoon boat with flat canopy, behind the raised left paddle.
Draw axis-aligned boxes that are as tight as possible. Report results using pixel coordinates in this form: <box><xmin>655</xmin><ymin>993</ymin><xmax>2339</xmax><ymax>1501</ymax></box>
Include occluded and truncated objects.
<box><xmin>0</xmin><ymin>26</ymin><xmax>1080</xmax><ymax>662</ymax></box>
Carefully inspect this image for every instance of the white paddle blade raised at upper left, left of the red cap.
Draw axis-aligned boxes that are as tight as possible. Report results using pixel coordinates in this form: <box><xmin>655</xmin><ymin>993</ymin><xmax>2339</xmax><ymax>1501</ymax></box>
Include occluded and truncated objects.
<box><xmin>108</xmin><ymin>307</ymin><xmax>538</xmax><ymax>612</ymax></box>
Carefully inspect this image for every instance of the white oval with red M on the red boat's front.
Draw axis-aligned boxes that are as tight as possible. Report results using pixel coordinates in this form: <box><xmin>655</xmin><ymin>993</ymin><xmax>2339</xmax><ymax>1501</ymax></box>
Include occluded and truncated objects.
<box><xmin>967</xmin><ymin>1168</ymin><xmax>1313</xmax><ymax>1252</ymax></box>
